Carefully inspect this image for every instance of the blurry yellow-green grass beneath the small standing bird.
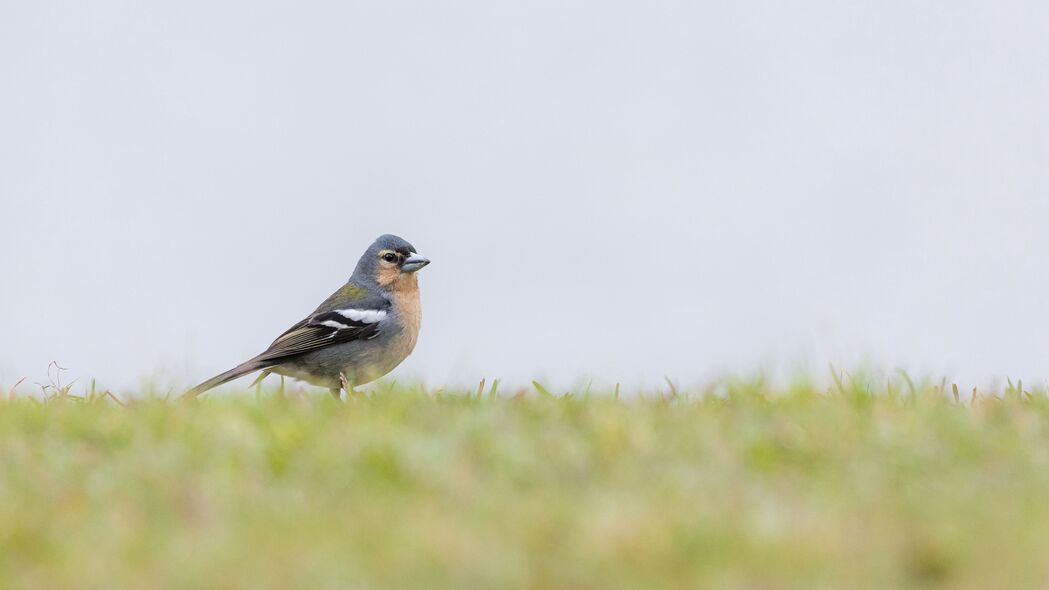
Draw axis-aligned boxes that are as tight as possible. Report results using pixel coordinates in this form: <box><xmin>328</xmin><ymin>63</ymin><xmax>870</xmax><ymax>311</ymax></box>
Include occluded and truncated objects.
<box><xmin>0</xmin><ymin>375</ymin><xmax>1049</xmax><ymax>589</ymax></box>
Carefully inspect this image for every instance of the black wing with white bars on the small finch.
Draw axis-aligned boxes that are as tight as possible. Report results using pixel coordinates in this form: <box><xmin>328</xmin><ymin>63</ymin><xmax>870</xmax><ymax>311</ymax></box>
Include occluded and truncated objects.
<box><xmin>253</xmin><ymin>299</ymin><xmax>389</xmax><ymax>364</ymax></box>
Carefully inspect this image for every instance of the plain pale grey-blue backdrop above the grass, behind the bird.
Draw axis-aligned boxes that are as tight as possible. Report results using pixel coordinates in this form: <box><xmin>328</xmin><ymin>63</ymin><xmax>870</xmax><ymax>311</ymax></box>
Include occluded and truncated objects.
<box><xmin>0</xmin><ymin>0</ymin><xmax>1049</xmax><ymax>388</ymax></box>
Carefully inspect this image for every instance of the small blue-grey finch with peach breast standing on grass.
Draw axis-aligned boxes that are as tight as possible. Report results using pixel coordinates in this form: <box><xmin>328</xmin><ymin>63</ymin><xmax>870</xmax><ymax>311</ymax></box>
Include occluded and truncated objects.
<box><xmin>183</xmin><ymin>234</ymin><xmax>430</xmax><ymax>399</ymax></box>
